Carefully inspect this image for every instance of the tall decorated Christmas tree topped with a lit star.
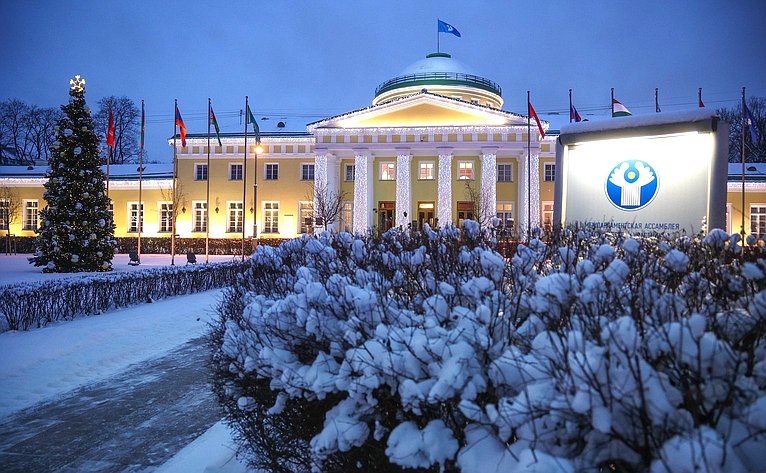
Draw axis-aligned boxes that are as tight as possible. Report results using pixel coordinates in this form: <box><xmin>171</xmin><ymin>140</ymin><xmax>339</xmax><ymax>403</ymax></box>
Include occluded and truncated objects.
<box><xmin>29</xmin><ymin>76</ymin><xmax>116</xmax><ymax>273</ymax></box>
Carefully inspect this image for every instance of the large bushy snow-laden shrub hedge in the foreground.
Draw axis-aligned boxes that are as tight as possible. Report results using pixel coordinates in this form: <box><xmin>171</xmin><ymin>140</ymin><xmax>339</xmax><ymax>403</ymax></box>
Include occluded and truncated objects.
<box><xmin>212</xmin><ymin>226</ymin><xmax>766</xmax><ymax>473</ymax></box>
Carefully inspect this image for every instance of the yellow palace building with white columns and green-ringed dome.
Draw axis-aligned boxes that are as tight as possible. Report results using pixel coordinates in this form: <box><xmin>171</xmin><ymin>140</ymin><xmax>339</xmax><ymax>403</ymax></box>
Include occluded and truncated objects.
<box><xmin>0</xmin><ymin>53</ymin><xmax>766</xmax><ymax>242</ymax></box>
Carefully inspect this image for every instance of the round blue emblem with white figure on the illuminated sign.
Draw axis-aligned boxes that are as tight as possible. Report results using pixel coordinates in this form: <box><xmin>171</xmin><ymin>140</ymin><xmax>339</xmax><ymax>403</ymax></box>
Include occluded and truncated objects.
<box><xmin>605</xmin><ymin>159</ymin><xmax>659</xmax><ymax>210</ymax></box>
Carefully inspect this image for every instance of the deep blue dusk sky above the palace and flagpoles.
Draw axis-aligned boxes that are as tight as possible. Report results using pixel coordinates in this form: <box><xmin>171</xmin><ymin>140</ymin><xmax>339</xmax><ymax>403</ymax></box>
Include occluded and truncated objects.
<box><xmin>0</xmin><ymin>0</ymin><xmax>766</xmax><ymax>162</ymax></box>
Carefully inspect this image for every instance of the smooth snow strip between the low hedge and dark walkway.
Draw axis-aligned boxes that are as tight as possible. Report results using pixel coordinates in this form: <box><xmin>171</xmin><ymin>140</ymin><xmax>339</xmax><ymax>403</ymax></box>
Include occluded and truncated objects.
<box><xmin>0</xmin><ymin>289</ymin><xmax>222</xmax><ymax>418</ymax></box>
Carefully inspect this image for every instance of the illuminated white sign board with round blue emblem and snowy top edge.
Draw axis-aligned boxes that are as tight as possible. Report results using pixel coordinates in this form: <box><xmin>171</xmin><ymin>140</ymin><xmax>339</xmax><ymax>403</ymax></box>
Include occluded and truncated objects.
<box><xmin>554</xmin><ymin>111</ymin><xmax>728</xmax><ymax>234</ymax></box>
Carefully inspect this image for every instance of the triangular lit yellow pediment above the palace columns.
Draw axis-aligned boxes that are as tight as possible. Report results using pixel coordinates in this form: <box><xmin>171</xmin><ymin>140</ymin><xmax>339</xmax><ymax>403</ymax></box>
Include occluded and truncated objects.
<box><xmin>314</xmin><ymin>93</ymin><xmax>526</xmax><ymax>128</ymax></box>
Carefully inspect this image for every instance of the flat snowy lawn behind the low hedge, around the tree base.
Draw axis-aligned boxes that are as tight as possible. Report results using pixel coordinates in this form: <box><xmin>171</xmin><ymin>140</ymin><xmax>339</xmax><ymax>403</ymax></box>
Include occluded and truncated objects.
<box><xmin>0</xmin><ymin>254</ymin><xmax>241</xmax><ymax>286</ymax></box>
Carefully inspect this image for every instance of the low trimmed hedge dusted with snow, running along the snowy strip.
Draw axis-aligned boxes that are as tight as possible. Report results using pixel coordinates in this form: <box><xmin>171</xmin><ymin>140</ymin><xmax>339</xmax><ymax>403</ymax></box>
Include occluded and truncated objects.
<box><xmin>0</xmin><ymin>262</ymin><xmax>246</xmax><ymax>332</ymax></box>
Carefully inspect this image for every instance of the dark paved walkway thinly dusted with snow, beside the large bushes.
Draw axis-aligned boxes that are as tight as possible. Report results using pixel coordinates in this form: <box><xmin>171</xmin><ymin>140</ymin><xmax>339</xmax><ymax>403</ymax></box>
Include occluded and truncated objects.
<box><xmin>0</xmin><ymin>338</ymin><xmax>222</xmax><ymax>473</ymax></box>
